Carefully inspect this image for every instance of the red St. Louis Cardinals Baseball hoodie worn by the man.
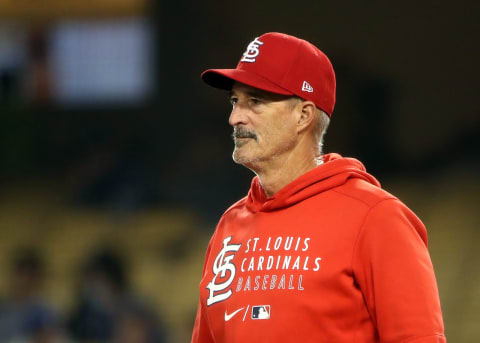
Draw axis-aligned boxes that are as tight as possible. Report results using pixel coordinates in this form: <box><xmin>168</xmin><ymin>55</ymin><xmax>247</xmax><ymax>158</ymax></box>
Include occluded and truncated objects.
<box><xmin>192</xmin><ymin>154</ymin><xmax>446</xmax><ymax>343</ymax></box>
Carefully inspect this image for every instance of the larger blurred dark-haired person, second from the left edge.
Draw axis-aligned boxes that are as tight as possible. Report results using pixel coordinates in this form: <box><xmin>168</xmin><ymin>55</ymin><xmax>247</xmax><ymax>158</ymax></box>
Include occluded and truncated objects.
<box><xmin>68</xmin><ymin>249</ymin><xmax>166</xmax><ymax>343</ymax></box>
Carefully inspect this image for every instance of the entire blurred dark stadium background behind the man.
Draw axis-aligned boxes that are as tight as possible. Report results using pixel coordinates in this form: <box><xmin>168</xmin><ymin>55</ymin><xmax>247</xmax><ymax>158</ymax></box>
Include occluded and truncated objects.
<box><xmin>0</xmin><ymin>0</ymin><xmax>480</xmax><ymax>343</ymax></box>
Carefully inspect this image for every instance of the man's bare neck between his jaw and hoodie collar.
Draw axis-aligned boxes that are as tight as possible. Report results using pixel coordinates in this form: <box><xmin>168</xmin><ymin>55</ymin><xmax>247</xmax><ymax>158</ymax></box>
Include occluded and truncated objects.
<box><xmin>254</xmin><ymin>153</ymin><xmax>319</xmax><ymax>197</ymax></box>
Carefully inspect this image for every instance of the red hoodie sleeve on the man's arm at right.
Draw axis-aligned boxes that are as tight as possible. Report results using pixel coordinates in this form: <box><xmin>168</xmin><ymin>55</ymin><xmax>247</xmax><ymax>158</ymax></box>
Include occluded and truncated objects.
<box><xmin>352</xmin><ymin>199</ymin><xmax>446</xmax><ymax>343</ymax></box>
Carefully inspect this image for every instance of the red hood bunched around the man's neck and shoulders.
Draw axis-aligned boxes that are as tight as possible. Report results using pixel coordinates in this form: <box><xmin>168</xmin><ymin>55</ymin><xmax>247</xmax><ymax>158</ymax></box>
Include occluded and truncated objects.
<box><xmin>246</xmin><ymin>154</ymin><xmax>380</xmax><ymax>212</ymax></box>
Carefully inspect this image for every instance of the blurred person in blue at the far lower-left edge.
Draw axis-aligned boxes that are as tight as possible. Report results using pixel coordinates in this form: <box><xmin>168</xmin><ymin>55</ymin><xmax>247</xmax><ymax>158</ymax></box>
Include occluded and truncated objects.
<box><xmin>0</xmin><ymin>249</ymin><xmax>61</xmax><ymax>343</ymax></box>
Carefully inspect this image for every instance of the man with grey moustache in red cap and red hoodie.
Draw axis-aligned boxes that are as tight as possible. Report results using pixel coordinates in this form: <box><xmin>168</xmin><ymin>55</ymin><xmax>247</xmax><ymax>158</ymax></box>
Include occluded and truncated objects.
<box><xmin>192</xmin><ymin>33</ymin><xmax>446</xmax><ymax>343</ymax></box>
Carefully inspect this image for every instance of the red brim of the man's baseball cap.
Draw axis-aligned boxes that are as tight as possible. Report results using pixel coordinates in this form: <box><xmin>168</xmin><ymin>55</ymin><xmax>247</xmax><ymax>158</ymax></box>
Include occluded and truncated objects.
<box><xmin>201</xmin><ymin>69</ymin><xmax>293</xmax><ymax>95</ymax></box>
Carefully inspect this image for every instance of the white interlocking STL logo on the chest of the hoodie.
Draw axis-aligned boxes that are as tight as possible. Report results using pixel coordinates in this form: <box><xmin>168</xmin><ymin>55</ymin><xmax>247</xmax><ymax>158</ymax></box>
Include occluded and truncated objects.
<box><xmin>207</xmin><ymin>236</ymin><xmax>242</xmax><ymax>306</ymax></box>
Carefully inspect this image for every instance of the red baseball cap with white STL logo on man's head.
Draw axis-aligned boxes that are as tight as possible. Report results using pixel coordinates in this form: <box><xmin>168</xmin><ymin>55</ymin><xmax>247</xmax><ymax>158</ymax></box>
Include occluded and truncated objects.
<box><xmin>201</xmin><ymin>32</ymin><xmax>335</xmax><ymax>116</ymax></box>
